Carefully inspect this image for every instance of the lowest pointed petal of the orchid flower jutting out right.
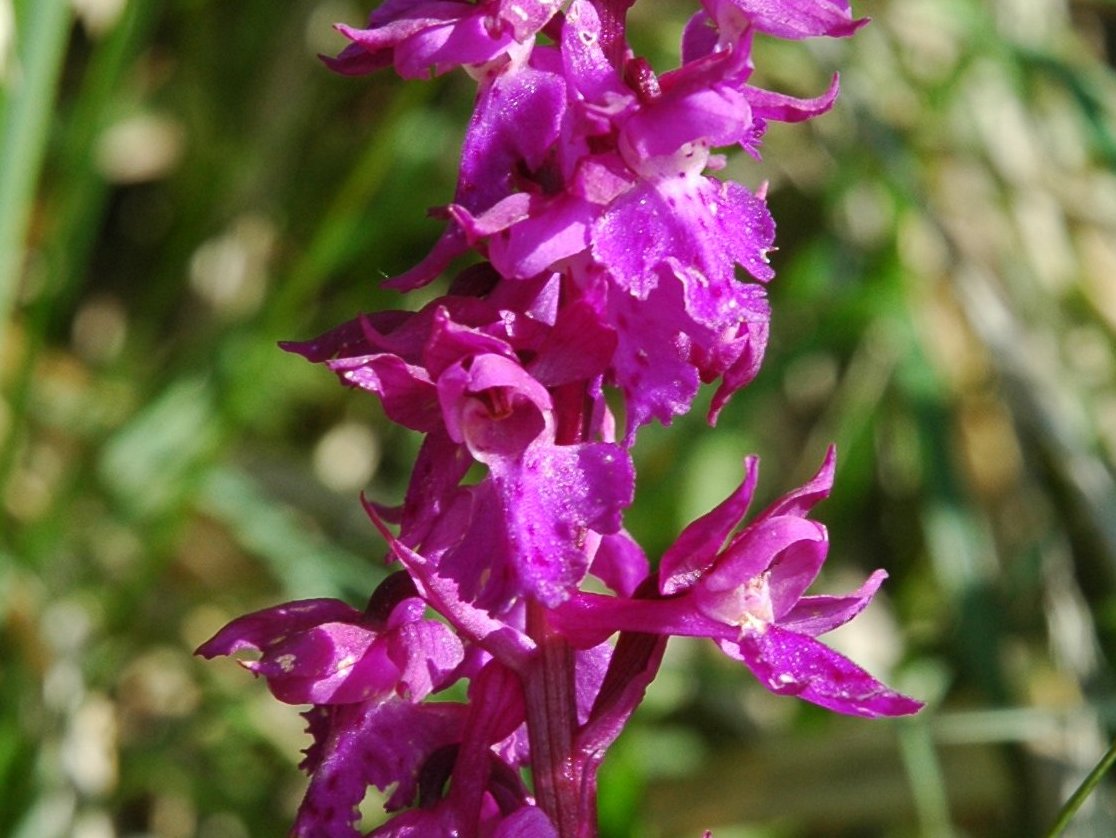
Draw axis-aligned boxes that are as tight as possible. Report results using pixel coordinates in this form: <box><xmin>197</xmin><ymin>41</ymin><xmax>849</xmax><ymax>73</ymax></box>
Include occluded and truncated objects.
<box><xmin>720</xmin><ymin>626</ymin><xmax>922</xmax><ymax>717</ymax></box>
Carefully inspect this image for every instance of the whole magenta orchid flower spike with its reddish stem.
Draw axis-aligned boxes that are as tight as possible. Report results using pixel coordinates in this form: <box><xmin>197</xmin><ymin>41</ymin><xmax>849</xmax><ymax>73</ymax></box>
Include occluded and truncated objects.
<box><xmin>199</xmin><ymin>0</ymin><xmax>921</xmax><ymax>838</ymax></box>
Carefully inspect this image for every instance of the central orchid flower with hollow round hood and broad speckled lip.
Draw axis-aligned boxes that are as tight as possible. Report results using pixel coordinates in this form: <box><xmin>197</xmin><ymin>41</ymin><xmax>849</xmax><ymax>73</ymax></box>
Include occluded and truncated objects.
<box><xmin>294</xmin><ymin>308</ymin><xmax>634</xmax><ymax>613</ymax></box>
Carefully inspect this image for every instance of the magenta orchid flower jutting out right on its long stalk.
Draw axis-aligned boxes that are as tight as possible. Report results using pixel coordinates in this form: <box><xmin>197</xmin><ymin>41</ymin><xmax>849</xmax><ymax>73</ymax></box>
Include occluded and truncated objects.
<box><xmin>554</xmin><ymin>449</ymin><xmax>922</xmax><ymax>716</ymax></box>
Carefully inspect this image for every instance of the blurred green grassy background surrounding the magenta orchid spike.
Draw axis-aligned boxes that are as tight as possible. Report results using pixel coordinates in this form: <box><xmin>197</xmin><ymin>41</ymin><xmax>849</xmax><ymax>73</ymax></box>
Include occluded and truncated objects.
<box><xmin>0</xmin><ymin>0</ymin><xmax>1116</xmax><ymax>838</ymax></box>
